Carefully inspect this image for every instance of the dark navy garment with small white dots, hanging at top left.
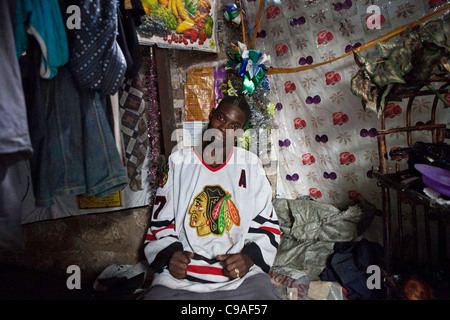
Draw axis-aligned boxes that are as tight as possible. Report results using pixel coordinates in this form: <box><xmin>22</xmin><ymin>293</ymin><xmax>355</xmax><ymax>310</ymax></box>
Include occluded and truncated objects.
<box><xmin>69</xmin><ymin>0</ymin><xmax>127</xmax><ymax>95</ymax></box>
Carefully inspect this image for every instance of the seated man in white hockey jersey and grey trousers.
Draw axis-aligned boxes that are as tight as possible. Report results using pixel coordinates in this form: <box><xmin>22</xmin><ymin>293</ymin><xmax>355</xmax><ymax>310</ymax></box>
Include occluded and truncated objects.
<box><xmin>145</xmin><ymin>96</ymin><xmax>281</xmax><ymax>300</ymax></box>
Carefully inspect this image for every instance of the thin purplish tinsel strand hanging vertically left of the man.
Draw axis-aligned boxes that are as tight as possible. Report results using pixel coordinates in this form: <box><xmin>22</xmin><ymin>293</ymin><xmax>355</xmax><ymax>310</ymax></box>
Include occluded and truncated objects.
<box><xmin>143</xmin><ymin>48</ymin><xmax>160</xmax><ymax>204</ymax></box>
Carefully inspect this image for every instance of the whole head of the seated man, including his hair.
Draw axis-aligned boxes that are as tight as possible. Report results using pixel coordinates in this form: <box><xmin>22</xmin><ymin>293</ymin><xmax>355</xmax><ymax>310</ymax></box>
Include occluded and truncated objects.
<box><xmin>208</xmin><ymin>96</ymin><xmax>252</xmax><ymax>142</ymax></box>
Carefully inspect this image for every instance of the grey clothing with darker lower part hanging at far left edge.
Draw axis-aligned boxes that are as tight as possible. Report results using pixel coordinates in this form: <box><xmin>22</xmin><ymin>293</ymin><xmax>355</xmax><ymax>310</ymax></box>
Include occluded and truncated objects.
<box><xmin>0</xmin><ymin>0</ymin><xmax>33</xmax><ymax>251</ymax></box>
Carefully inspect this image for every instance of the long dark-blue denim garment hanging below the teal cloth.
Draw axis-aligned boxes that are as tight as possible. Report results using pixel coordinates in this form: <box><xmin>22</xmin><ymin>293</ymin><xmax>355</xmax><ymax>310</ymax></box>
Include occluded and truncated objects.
<box><xmin>20</xmin><ymin>41</ymin><xmax>128</xmax><ymax>207</ymax></box>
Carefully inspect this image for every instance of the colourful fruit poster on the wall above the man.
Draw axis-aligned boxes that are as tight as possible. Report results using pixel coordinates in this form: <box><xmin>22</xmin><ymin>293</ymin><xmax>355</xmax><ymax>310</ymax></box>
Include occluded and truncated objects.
<box><xmin>137</xmin><ymin>0</ymin><xmax>218</xmax><ymax>52</ymax></box>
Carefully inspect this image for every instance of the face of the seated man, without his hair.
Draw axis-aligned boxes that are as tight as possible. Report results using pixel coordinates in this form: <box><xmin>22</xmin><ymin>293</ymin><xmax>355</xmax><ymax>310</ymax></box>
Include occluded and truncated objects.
<box><xmin>208</xmin><ymin>104</ymin><xmax>247</xmax><ymax>145</ymax></box>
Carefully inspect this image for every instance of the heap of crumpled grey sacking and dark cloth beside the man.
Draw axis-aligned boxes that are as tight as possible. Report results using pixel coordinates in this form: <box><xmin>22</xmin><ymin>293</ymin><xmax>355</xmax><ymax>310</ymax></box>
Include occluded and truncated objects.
<box><xmin>271</xmin><ymin>197</ymin><xmax>383</xmax><ymax>299</ymax></box>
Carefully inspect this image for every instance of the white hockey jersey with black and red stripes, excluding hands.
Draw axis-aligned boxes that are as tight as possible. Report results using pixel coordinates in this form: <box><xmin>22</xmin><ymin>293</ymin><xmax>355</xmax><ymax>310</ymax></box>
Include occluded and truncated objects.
<box><xmin>145</xmin><ymin>147</ymin><xmax>280</xmax><ymax>292</ymax></box>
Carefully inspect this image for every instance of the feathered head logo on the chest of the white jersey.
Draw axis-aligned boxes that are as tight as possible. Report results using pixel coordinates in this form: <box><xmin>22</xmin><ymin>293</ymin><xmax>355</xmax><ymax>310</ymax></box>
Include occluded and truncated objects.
<box><xmin>188</xmin><ymin>185</ymin><xmax>240</xmax><ymax>237</ymax></box>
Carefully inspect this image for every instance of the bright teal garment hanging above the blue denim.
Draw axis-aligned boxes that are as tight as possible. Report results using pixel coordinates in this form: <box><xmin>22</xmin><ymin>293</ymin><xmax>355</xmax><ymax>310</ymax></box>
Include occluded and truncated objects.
<box><xmin>15</xmin><ymin>0</ymin><xmax>69</xmax><ymax>79</ymax></box>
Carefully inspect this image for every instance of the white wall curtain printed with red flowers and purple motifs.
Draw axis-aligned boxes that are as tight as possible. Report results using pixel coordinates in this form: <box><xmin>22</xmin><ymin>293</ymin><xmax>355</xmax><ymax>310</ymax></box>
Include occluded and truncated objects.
<box><xmin>242</xmin><ymin>0</ymin><xmax>450</xmax><ymax>205</ymax></box>
